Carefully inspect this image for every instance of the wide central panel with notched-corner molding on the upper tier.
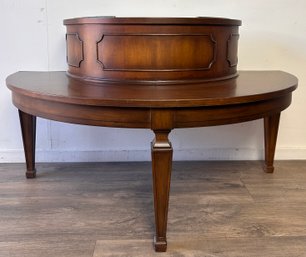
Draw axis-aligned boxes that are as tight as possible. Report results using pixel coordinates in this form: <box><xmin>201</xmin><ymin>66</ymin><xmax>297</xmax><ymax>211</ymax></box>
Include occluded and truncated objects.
<box><xmin>97</xmin><ymin>34</ymin><xmax>216</xmax><ymax>71</ymax></box>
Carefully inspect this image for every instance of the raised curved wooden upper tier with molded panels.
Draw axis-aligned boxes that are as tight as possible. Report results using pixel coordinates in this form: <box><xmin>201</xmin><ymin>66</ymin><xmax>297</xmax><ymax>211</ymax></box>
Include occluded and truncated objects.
<box><xmin>64</xmin><ymin>17</ymin><xmax>241</xmax><ymax>84</ymax></box>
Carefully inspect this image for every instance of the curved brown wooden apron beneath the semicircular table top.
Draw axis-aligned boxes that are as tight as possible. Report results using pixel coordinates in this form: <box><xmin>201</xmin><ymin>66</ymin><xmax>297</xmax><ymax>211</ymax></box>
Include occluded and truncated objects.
<box><xmin>12</xmin><ymin>92</ymin><xmax>291</xmax><ymax>130</ymax></box>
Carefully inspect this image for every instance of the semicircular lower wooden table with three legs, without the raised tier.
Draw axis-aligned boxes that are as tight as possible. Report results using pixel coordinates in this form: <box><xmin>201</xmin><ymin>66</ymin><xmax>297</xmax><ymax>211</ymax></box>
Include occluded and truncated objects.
<box><xmin>6</xmin><ymin>71</ymin><xmax>297</xmax><ymax>251</ymax></box>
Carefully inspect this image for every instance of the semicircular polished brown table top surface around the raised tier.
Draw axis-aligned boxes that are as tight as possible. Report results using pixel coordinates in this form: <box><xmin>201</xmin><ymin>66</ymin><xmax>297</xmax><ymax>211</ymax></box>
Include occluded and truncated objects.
<box><xmin>6</xmin><ymin>71</ymin><xmax>298</xmax><ymax>108</ymax></box>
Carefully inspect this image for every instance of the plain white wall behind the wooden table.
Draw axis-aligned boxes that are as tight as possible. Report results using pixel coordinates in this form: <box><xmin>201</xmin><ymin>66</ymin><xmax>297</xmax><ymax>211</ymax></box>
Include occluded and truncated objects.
<box><xmin>0</xmin><ymin>0</ymin><xmax>306</xmax><ymax>162</ymax></box>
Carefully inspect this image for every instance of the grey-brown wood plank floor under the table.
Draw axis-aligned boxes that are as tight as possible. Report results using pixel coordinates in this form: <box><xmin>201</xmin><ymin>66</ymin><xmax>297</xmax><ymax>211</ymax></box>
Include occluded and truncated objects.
<box><xmin>0</xmin><ymin>161</ymin><xmax>306</xmax><ymax>257</ymax></box>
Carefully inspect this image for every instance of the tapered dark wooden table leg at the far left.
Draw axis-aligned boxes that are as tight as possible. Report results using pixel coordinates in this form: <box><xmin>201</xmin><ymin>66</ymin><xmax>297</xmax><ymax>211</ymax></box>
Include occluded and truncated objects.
<box><xmin>19</xmin><ymin>110</ymin><xmax>36</xmax><ymax>178</ymax></box>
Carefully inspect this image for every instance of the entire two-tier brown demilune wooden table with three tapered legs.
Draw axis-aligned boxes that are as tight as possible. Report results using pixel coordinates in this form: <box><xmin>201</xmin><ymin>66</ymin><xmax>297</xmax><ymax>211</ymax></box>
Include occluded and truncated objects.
<box><xmin>6</xmin><ymin>17</ymin><xmax>298</xmax><ymax>252</ymax></box>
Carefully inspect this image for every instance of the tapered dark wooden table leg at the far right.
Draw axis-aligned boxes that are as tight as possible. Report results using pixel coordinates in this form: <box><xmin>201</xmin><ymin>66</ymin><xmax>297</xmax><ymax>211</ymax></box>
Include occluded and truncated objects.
<box><xmin>264</xmin><ymin>113</ymin><xmax>280</xmax><ymax>173</ymax></box>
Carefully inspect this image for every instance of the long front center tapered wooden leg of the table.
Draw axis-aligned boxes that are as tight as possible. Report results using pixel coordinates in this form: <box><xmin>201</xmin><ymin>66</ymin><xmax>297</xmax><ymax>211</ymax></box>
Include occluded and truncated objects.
<box><xmin>151</xmin><ymin>128</ymin><xmax>173</xmax><ymax>252</ymax></box>
